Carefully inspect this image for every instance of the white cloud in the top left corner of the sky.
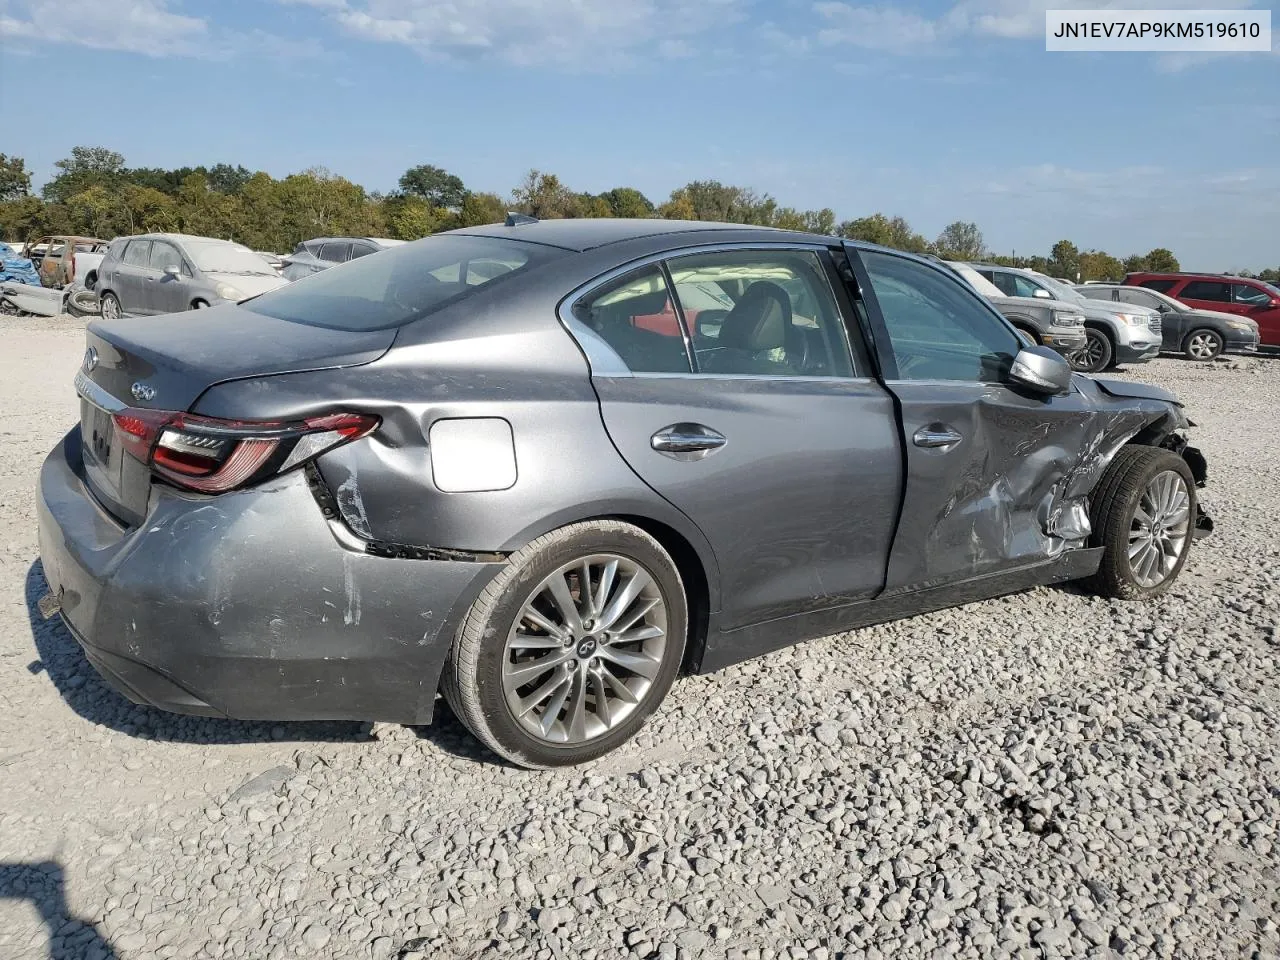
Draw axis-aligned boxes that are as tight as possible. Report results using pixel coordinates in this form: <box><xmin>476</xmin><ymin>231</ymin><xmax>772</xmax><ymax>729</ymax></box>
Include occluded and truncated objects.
<box><xmin>0</xmin><ymin>0</ymin><xmax>209</xmax><ymax>56</ymax></box>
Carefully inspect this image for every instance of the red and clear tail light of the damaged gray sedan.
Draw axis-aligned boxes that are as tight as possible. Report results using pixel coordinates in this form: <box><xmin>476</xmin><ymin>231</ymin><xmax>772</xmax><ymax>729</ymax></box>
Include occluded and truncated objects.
<box><xmin>113</xmin><ymin>408</ymin><xmax>379</xmax><ymax>493</ymax></box>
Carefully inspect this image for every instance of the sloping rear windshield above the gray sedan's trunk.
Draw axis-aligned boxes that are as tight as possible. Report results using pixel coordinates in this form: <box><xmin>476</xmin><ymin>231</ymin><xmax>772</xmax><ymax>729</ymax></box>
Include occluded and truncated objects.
<box><xmin>241</xmin><ymin>234</ymin><xmax>563</xmax><ymax>330</ymax></box>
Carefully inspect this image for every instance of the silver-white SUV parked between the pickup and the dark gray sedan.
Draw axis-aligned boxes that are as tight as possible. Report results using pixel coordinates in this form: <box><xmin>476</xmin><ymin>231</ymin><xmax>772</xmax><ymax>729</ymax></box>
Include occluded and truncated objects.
<box><xmin>970</xmin><ymin>264</ymin><xmax>1164</xmax><ymax>372</ymax></box>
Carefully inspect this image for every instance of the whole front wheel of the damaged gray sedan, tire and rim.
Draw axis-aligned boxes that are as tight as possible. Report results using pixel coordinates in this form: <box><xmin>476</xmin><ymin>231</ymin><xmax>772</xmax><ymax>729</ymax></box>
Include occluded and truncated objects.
<box><xmin>1089</xmin><ymin>445</ymin><xmax>1196</xmax><ymax>600</ymax></box>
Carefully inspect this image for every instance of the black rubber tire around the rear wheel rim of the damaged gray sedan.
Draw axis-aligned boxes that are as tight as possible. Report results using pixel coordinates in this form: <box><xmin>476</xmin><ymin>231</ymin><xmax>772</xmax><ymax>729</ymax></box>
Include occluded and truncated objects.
<box><xmin>442</xmin><ymin>520</ymin><xmax>689</xmax><ymax>769</ymax></box>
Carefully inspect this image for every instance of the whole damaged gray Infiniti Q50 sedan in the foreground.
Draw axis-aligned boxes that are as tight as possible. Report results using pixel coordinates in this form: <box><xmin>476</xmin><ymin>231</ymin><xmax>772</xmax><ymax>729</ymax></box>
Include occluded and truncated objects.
<box><xmin>38</xmin><ymin>218</ymin><xmax>1211</xmax><ymax>767</ymax></box>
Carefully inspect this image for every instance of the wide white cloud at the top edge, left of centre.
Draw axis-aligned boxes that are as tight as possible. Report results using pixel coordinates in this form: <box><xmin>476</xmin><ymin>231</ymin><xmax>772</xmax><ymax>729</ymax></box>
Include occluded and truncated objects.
<box><xmin>278</xmin><ymin>0</ymin><xmax>744</xmax><ymax>70</ymax></box>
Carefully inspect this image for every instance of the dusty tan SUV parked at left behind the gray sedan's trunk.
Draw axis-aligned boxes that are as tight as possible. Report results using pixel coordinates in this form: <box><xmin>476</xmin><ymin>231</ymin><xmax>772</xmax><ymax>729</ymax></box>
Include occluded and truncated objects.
<box><xmin>97</xmin><ymin>233</ymin><xmax>293</xmax><ymax>319</ymax></box>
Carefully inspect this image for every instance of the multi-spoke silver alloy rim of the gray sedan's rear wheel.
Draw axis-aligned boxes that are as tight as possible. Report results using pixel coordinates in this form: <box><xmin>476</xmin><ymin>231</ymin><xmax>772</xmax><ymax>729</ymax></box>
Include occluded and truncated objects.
<box><xmin>502</xmin><ymin>553</ymin><xmax>669</xmax><ymax>745</ymax></box>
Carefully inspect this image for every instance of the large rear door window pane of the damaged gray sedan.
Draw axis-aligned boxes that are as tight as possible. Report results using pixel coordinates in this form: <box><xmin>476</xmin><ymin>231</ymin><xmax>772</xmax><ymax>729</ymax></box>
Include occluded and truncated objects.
<box><xmin>667</xmin><ymin>250</ymin><xmax>854</xmax><ymax>376</ymax></box>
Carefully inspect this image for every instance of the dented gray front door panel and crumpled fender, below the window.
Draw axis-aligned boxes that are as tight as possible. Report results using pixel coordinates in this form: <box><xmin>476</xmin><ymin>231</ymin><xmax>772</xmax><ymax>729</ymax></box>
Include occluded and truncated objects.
<box><xmin>886</xmin><ymin>378</ymin><xmax>1185</xmax><ymax>595</ymax></box>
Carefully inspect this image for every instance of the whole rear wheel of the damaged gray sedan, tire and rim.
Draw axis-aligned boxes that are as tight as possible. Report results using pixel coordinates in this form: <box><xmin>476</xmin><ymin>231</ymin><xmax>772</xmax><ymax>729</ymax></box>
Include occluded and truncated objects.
<box><xmin>442</xmin><ymin>520</ymin><xmax>687</xmax><ymax>769</ymax></box>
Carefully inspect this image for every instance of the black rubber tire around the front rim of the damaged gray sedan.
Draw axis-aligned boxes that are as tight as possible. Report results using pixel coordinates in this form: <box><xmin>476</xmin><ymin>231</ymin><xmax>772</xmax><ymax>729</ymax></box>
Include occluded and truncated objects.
<box><xmin>1089</xmin><ymin>444</ymin><xmax>1196</xmax><ymax>600</ymax></box>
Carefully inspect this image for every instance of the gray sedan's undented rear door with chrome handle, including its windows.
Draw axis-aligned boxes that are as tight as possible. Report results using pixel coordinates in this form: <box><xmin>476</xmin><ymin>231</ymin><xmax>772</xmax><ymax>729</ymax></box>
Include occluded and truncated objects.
<box><xmin>566</xmin><ymin>244</ymin><xmax>902</xmax><ymax>630</ymax></box>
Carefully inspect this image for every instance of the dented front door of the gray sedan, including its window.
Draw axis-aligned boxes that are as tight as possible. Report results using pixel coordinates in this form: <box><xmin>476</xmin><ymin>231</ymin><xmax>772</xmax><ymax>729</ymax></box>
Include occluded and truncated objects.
<box><xmin>847</xmin><ymin>247</ymin><xmax>1096</xmax><ymax>595</ymax></box>
